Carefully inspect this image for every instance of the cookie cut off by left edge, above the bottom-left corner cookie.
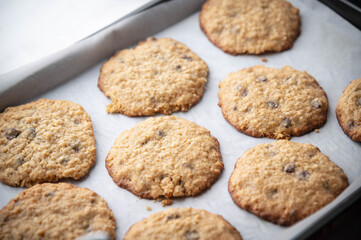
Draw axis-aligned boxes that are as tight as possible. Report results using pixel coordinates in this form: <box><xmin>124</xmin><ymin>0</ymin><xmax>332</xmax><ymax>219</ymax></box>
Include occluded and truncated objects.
<box><xmin>0</xmin><ymin>99</ymin><xmax>96</xmax><ymax>187</ymax></box>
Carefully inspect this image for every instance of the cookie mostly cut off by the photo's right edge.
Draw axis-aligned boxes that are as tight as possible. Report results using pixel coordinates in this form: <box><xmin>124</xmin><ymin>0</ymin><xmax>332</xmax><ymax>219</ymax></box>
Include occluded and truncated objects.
<box><xmin>336</xmin><ymin>78</ymin><xmax>361</xmax><ymax>142</ymax></box>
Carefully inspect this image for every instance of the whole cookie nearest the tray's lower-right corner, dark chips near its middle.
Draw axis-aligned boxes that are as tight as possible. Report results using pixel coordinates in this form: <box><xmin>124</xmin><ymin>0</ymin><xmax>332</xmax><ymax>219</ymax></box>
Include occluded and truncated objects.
<box><xmin>228</xmin><ymin>140</ymin><xmax>348</xmax><ymax>226</ymax></box>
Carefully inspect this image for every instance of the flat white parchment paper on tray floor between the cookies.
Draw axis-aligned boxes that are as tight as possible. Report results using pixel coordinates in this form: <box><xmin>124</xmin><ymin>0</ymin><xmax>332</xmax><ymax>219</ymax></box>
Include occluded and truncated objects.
<box><xmin>0</xmin><ymin>1</ymin><xmax>361</xmax><ymax>239</ymax></box>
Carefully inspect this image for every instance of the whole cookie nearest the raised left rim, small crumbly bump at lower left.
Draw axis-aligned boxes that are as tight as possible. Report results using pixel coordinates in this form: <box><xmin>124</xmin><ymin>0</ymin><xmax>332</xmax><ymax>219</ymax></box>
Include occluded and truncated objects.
<box><xmin>98</xmin><ymin>38</ymin><xmax>208</xmax><ymax>116</ymax></box>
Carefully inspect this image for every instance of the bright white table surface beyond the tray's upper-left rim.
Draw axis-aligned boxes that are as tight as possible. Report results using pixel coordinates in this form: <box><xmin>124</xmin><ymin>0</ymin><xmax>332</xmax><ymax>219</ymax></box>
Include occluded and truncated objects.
<box><xmin>0</xmin><ymin>0</ymin><xmax>151</xmax><ymax>74</ymax></box>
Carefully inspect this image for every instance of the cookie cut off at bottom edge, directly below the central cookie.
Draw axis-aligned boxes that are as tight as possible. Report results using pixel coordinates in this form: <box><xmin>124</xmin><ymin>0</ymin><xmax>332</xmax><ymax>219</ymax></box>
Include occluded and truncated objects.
<box><xmin>124</xmin><ymin>208</ymin><xmax>242</xmax><ymax>240</ymax></box>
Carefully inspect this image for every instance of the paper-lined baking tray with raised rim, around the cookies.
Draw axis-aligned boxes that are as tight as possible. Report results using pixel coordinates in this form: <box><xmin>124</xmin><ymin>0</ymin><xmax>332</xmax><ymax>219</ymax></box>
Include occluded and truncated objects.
<box><xmin>0</xmin><ymin>0</ymin><xmax>361</xmax><ymax>240</ymax></box>
